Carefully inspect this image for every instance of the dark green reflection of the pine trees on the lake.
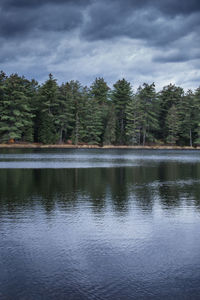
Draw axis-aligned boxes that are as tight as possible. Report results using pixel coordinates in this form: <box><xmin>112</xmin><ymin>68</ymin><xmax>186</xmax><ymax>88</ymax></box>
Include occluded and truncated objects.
<box><xmin>0</xmin><ymin>163</ymin><xmax>200</xmax><ymax>217</ymax></box>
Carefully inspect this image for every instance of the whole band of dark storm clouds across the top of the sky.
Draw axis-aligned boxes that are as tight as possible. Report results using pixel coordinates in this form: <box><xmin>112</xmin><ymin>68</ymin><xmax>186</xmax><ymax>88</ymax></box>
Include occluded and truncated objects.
<box><xmin>0</xmin><ymin>0</ymin><xmax>200</xmax><ymax>46</ymax></box>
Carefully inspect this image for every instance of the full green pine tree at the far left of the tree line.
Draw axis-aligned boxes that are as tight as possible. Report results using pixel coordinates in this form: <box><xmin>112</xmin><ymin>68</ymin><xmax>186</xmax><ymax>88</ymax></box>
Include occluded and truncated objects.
<box><xmin>0</xmin><ymin>74</ymin><xmax>34</xmax><ymax>142</ymax></box>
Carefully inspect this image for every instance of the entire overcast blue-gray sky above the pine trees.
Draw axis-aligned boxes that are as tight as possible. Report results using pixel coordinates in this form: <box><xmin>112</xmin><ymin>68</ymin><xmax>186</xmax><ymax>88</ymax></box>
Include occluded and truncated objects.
<box><xmin>0</xmin><ymin>0</ymin><xmax>200</xmax><ymax>90</ymax></box>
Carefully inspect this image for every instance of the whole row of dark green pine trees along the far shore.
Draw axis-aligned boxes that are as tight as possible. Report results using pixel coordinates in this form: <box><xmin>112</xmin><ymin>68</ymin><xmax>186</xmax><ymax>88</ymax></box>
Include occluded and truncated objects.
<box><xmin>0</xmin><ymin>71</ymin><xmax>200</xmax><ymax>146</ymax></box>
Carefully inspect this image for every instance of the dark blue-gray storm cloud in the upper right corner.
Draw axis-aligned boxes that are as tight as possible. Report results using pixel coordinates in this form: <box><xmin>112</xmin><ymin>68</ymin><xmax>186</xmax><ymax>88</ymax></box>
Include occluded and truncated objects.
<box><xmin>83</xmin><ymin>0</ymin><xmax>200</xmax><ymax>45</ymax></box>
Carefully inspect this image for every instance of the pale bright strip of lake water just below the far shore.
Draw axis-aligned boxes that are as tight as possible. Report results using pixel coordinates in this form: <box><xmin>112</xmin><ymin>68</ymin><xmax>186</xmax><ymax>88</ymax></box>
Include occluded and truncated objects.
<box><xmin>0</xmin><ymin>149</ymin><xmax>200</xmax><ymax>168</ymax></box>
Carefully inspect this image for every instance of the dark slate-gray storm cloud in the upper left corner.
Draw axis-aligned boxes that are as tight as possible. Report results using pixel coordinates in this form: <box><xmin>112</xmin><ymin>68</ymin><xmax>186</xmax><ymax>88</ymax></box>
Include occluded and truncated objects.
<box><xmin>0</xmin><ymin>0</ymin><xmax>90</xmax><ymax>39</ymax></box>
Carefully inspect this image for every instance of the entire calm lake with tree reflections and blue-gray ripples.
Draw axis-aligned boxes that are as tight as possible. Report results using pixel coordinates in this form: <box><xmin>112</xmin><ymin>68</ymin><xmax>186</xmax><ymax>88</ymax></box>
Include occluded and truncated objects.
<box><xmin>0</xmin><ymin>149</ymin><xmax>200</xmax><ymax>300</ymax></box>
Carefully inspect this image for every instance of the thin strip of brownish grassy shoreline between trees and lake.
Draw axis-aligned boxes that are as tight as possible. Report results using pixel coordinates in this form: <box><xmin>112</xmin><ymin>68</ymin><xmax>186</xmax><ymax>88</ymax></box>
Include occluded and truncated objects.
<box><xmin>0</xmin><ymin>143</ymin><xmax>200</xmax><ymax>150</ymax></box>
